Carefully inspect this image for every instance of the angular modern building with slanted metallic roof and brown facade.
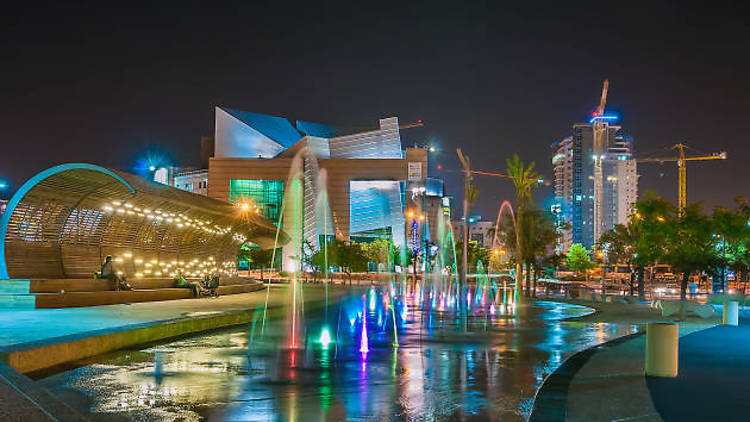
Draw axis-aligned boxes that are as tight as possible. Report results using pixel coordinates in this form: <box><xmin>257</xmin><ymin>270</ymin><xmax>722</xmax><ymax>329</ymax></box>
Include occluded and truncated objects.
<box><xmin>202</xmin><ymin>107</ymin><xmax>444</xmax><ymax>269</ymax></box>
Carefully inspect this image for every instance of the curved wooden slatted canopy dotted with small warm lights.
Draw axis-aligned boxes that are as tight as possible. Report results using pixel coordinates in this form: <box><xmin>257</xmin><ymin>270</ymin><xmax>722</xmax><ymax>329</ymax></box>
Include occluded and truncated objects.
<box><xmin>0</xmin><ymin>164</ymin><xmax>286</xmax><ymax>279</ymax></box>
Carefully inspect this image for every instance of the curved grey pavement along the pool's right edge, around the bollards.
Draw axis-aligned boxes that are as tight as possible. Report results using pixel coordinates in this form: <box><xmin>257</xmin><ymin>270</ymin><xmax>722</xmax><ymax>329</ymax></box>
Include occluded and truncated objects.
<box><xmin>531</xmin><ymin>303</ymin><xmax>724</xmax><ymax>421</ymax></box>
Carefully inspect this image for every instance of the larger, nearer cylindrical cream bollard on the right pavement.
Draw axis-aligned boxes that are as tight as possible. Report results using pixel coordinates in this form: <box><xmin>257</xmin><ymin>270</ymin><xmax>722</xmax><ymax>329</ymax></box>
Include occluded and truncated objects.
<box><xmin>646</xmin><ymin>322</ymin><xmax>680</xmax><ymax>378</ymax></box>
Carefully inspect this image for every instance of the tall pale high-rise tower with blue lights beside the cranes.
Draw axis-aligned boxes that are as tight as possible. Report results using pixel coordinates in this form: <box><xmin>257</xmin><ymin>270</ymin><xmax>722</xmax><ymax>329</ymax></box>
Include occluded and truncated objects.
<box><xmin>551</xmin><ymin>116</ymin><xmax>638</xmax><ymax>251</ymax></box>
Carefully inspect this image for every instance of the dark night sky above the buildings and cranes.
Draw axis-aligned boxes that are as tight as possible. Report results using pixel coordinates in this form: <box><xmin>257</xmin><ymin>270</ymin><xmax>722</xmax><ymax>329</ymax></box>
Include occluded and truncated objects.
<box><xmin>0</xmin><ymin>0</ymin><xmax>750</xmax><ymax>218</ymax></box>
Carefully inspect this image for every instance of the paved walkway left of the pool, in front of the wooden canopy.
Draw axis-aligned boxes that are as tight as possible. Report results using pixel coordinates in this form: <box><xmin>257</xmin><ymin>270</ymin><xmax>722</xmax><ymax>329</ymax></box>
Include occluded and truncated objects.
<box><xmin>0</xmin><ymin>285</ymin><xmax>349</xmax><ymax>421</ymax></box>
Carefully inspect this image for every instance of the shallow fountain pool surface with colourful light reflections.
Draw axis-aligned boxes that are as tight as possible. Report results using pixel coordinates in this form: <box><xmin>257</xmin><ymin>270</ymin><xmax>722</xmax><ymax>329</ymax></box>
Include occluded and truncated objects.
<box><xmin>39</xmin><ymin>297</ymin><xmax>638</xmax><ymax>421</ymax></box>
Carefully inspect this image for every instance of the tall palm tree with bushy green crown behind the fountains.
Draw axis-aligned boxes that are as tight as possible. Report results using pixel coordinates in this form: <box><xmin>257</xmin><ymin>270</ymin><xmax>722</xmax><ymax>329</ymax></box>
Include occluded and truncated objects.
<box><xmin>506</xmin><ymin>154</ymin><xmax>539</xmax><ymax>293</ymax></box>
